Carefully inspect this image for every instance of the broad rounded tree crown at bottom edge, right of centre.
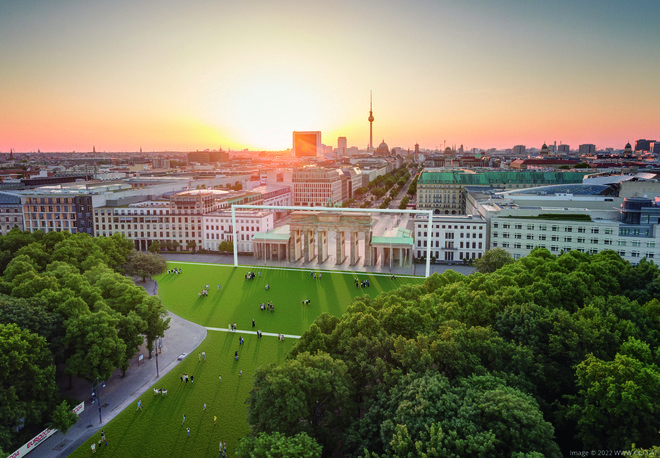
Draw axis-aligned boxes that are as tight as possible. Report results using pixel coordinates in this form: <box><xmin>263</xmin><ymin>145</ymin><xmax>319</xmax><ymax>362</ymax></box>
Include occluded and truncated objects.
<box><xmin>349</xmin><ymin>373</ymin><xmax>561</xmax><ymax>458</ymax></box>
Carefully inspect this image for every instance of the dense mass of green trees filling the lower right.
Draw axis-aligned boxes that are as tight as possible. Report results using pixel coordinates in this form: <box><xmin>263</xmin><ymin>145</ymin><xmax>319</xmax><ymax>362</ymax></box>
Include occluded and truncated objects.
<box><xmin>239</xmin><ymin>249</ymin><xmax>660</xmax><ymax>457</ymax></box>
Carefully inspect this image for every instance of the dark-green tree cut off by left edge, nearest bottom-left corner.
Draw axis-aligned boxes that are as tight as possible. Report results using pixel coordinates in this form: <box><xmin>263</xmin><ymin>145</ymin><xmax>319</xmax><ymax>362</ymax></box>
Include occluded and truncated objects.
<box><xmin>0</xmin><ymin>324</ymin><xmax>58</xmax><ymax>450</ymax></box>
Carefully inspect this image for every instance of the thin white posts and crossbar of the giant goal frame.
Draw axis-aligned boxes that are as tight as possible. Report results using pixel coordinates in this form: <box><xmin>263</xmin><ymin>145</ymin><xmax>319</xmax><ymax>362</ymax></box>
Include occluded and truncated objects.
<box><xmin>231</xmin><ymin>205</ymin><xmax>433</xmax><ymax>277</ymax></box>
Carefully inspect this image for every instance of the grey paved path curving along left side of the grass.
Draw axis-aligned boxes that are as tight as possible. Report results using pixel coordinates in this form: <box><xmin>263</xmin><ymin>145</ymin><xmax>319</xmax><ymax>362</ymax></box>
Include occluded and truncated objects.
<box><xmin>27</xmin><ymin>280</ymin><xmax>206</xmax><ymax>458</ymax></box>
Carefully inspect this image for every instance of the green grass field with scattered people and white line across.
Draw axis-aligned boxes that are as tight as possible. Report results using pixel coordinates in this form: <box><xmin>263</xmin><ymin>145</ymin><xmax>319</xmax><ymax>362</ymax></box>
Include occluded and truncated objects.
<box><xmin>71</xmin><ymin>263</ymin><xmax>422</xmax><ymax>458</ymax></box>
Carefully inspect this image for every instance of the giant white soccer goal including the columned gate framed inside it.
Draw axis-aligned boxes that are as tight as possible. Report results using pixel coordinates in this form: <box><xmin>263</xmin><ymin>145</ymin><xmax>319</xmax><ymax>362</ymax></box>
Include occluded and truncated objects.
<box><xmin>231</xmin><ymin>205</ymin><xmax>433</xmax><ymax>277</ymax></box>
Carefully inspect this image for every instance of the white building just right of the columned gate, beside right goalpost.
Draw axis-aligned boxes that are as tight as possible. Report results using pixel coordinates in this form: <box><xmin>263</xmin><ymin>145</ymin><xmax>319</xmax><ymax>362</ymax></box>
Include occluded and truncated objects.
<box><xmin>414</xmin><ymin>215</ymin><xmax>488</xmax><ymax>262</ymax></box>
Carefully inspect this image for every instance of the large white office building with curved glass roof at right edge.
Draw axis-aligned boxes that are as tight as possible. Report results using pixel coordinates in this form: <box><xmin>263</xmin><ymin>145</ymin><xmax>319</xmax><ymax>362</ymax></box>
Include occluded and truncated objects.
<box><xmin>479</xmin><ymin>182</ymin><xmax>660</xmax><ymax>264</ymax></box>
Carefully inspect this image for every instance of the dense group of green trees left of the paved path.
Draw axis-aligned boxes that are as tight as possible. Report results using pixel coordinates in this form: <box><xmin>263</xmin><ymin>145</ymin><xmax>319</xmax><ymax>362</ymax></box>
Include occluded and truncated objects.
<box><xmin>0</xmin><ymin>230</ymin><xmax>169</xmax><ymax>450</ymax></box>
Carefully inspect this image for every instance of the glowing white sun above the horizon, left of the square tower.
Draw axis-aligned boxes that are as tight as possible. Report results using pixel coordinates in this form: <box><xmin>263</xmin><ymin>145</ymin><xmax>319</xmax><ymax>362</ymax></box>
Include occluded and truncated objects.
<box><xmin>202</xmin><ymin>72</ymin><xmax>323</xmax><ymax>150</ymax></box>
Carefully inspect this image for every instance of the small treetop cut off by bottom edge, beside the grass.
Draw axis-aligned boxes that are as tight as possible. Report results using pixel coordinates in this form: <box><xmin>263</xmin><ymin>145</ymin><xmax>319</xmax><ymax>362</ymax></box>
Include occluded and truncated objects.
<box><xmin>235</xmin><ymin>431</ymin><xmax>322</xmax><ymax>458</ymax></box>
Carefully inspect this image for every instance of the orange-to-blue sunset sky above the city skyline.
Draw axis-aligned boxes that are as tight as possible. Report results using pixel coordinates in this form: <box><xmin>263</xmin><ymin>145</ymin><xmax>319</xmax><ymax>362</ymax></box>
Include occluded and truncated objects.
<box><xmin>0</xmin><ymin>0</ymin><xmax>660</xmax><ymax>152</ymax></box>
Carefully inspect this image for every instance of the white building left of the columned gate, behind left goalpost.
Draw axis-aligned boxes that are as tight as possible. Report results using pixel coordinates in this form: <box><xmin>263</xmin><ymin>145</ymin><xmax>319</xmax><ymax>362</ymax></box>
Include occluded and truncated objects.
<box><xmin>202</xmin><ymin>210</ymin><xmax>274</xmax><ymax>253</ymax></box>
